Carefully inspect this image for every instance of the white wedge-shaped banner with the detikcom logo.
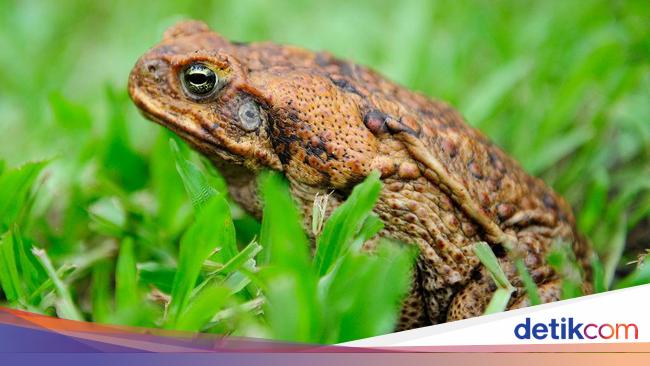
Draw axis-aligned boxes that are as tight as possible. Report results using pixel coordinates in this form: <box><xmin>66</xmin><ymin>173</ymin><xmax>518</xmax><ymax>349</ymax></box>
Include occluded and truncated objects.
<box><xmin>342</xmin><ymin>285</ymin><xmax>650</xmax><ymax>347</ymax></box>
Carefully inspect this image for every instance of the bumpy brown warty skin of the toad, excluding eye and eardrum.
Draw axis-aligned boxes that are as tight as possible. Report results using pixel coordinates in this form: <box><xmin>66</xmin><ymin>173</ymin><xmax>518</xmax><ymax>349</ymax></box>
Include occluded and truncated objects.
<box><xmin>129</xmin><ymin>21</ymin><xmax>590</xmax><ymax>329</ymax></box>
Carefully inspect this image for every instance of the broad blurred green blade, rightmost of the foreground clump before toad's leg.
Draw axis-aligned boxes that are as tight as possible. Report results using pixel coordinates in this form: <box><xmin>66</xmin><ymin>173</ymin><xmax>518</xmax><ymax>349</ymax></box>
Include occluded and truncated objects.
<box><xmin>317</xmin><ymin>239</ymin><xmax>417</xmax><ymax>343</ymax></box>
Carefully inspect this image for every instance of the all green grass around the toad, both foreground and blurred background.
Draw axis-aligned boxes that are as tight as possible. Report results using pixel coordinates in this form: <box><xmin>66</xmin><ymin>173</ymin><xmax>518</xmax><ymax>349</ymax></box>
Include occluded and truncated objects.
<box><xmin>0</xmin><ymin>0</ymin><xmax>650</xmax><ymax>342</ymax></box>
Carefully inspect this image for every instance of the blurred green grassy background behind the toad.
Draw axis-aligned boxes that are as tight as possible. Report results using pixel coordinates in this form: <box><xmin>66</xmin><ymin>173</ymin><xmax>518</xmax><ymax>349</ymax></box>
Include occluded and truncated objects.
<box><xmin>0</xmin><ymin>0</ymin><xmax>650</xmax><ymax>342</ymax></box>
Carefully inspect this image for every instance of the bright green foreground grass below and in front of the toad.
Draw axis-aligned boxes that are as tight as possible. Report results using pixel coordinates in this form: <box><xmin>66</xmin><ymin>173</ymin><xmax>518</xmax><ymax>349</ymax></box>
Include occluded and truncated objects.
<box><xmin>0</xmin><ymin>140</ymin><xmax>415</xmax><ymax>343</ymax></box>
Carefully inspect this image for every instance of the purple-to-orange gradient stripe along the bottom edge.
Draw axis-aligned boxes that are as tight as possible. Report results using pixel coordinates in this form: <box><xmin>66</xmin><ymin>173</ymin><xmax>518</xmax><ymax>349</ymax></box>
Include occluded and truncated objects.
<box><xmin>0</xmin><ymin>308</ymin><xmax>650</xmax><ymax>366</ymax></box>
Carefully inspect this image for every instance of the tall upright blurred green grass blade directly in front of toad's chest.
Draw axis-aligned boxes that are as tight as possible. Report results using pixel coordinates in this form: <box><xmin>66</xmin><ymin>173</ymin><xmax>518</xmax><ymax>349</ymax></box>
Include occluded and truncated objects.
<box><xmin>259</xmin><ymin>172</ymin><xmax>322</xmax><ymax>342</ymax></box>
